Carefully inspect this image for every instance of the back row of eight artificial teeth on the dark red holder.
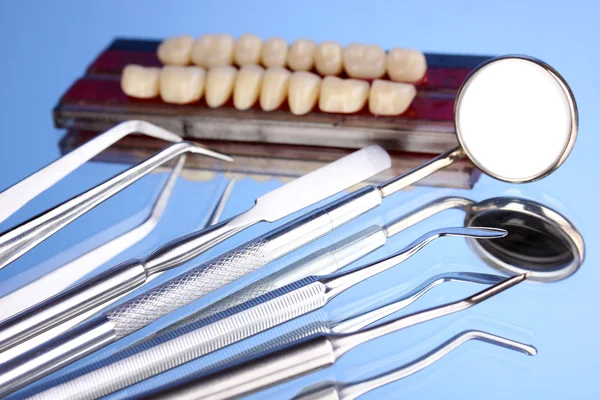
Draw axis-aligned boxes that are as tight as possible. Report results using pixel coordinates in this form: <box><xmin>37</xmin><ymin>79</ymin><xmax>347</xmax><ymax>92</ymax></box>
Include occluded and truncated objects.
<box><xmin>158</xmin><ymin>34</ymin><xmax>427</xmax><ymax>83</ymax></box>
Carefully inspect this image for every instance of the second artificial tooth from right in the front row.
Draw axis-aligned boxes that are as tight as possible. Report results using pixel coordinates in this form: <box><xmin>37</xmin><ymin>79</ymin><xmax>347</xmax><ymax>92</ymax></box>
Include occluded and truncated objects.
<box><xmin>319</xmin><ymin>76</ymin><xmax>369</xmax><ymax>114</ymax></box>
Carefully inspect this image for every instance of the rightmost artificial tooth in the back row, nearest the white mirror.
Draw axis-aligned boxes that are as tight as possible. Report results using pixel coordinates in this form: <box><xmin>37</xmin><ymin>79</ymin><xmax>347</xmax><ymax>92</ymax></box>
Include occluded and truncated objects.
<box><xmin>385</xmin><ymin>47</ymin><xmax>427</xmax><ymax>83</ymax></box>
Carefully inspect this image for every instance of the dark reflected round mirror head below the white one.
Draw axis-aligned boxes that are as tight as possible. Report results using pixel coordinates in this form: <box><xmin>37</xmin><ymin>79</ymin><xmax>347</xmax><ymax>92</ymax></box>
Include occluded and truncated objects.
<box><xmin>465</xmin><ymin>197</ymin><xmax>585</xmax><ymax>282</ymax></box>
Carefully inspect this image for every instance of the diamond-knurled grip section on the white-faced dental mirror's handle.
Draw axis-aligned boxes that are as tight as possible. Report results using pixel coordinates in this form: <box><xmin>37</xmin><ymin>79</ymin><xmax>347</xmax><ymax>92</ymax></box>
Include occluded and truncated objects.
<box><xmin>105</xmin><ymin>239</ymin><xmax>272</xmax><ymax>338</ymax></box>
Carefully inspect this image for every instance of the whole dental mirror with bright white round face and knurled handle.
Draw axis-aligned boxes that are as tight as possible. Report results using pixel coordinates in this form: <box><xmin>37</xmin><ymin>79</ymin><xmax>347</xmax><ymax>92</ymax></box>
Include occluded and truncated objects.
<box><xmin>0</xmin><ymin>56</ymin><xmax>578</xmax><ymax>391</ymax></box>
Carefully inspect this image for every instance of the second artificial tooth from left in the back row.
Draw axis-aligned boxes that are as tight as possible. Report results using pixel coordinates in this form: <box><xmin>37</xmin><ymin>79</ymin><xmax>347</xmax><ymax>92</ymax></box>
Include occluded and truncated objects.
<box><xmin>192</xmin><ymin>33</ymin><xmax>235</xmax><ymax>68</ymax></box>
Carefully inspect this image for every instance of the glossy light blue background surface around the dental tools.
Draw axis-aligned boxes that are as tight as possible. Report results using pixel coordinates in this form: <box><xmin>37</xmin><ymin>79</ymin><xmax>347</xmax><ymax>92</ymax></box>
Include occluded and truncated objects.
<box><xmin>0</xmin><ymin>0</ymin><xmax>600</xmax><ymax>399</ymax></box>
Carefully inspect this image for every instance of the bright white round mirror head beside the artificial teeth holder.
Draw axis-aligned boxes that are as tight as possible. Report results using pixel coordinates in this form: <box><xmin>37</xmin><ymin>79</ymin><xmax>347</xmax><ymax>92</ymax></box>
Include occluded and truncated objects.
<box><xmin>454</xmin><ymin>56</ymin><xmax>578</xmax><ymax>183</ymax></box>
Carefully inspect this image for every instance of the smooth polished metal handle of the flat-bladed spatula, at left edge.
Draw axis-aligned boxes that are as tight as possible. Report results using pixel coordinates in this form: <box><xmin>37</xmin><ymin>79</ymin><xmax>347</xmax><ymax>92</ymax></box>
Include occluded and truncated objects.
<box><xmin>0</xmin><ymin>260</ymin><xmax>146</xmax><ymax>352</ymax></box>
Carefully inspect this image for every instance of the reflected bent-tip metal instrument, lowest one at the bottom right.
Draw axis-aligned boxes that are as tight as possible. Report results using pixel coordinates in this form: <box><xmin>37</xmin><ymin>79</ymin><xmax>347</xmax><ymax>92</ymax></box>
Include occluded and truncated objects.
<box><xmin>293</xmin><ymin>330</ymin><xmax>537</xmax><ymax>400</ymax></box>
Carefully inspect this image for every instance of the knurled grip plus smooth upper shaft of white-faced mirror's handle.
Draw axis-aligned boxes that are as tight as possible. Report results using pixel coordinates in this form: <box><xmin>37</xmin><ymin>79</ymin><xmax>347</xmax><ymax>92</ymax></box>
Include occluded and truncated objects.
<box><xmin>106</xmin><ymin>187</ymin><xmax>381</xmax><ymax>337</ymax></box>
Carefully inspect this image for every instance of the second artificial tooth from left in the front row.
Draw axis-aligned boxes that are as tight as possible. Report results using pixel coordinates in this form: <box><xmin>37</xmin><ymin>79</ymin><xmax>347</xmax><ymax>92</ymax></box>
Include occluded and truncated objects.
<box><xmin>160</xmin><ymin>65</ymin><xmax>206</xmax><ymax>104</ymax></box>
